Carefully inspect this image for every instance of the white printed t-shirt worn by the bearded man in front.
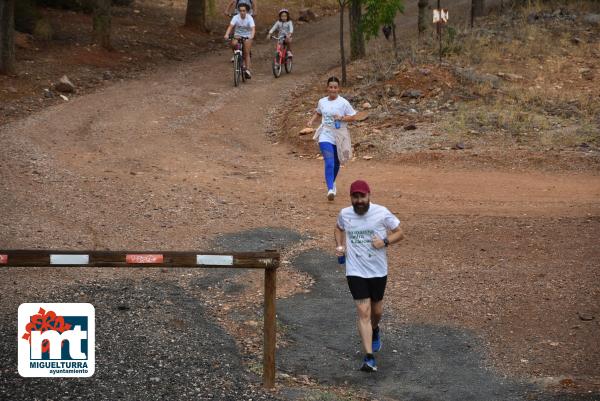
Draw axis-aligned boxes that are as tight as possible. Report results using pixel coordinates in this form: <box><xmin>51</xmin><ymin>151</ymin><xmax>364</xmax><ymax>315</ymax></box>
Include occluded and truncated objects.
<box><xmin>337</xmin><ymin>203</ymin><xmax>400</xmax><ymax>278</ymax></box>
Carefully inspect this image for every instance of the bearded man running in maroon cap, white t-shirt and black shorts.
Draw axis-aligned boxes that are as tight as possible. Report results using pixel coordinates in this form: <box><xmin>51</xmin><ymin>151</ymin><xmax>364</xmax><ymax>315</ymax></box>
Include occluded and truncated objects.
<box><xmin>334</xmin><ymin>180</ymin><xmax>404</xmax><ymax>372</ymax></box>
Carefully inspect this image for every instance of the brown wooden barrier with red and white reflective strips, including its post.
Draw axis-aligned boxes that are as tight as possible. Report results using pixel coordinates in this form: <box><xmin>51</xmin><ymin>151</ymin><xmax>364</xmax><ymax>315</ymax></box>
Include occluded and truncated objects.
<box><xmin>0</xmin><ymin>249</ymin><xmax>279</xmax><ymax>388</ymax></box>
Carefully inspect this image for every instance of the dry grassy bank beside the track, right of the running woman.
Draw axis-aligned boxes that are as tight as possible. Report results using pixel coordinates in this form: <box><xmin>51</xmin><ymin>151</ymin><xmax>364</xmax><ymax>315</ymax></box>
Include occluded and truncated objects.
<box><xmin>287</xmin><ymin>0</ymin><xmax>600</xmax><ymax>168</ymax></box>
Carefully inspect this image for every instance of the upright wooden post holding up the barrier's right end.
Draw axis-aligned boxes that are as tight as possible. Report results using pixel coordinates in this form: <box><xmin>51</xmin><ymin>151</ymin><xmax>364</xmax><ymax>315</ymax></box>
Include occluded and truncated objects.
<box><xmin>263</xmin><ymin>268</ymin><xmax>277</xmax><ymax>388</ymax></box>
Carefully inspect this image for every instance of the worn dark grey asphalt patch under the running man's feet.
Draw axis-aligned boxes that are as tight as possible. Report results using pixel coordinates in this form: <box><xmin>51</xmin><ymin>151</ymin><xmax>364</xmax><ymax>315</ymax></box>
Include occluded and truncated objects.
<box><xmin>279</xmin><ymin>250</ymin><xmax>599</xmax><ymax>401</ymax></box>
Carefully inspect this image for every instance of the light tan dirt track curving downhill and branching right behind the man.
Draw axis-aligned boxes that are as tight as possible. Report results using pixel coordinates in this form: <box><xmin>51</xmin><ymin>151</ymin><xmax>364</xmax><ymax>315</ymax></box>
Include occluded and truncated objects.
<box><xmin>0</xmin><ymin>7</ymin><xmax>599</xmax><ymax>248</ymax></box>
